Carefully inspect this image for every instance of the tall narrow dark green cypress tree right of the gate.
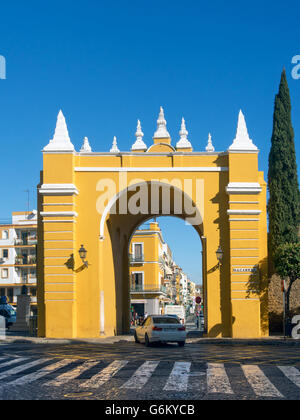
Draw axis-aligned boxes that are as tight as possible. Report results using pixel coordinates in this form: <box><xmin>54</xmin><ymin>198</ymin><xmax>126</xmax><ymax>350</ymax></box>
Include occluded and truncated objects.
<box><xmin>268</xmin><ymin>70</ymin><xmax>300</xmax><ymax>266</ymax></box>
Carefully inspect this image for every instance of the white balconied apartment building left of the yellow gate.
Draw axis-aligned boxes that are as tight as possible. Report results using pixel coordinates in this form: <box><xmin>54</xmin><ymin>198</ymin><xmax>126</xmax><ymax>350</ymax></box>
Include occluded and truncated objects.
<box><xmin>0</xmin><ymin>210</ymin><xmax>37</xmax><ymax>313</ymax></box>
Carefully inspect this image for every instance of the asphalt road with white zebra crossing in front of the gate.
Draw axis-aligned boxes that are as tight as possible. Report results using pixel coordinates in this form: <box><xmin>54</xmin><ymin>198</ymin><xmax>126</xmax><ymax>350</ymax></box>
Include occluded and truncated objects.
<box><xmin>0</xmin><ymin>340</ymin><xmax>300</xmax><ymax>401</ymax></box>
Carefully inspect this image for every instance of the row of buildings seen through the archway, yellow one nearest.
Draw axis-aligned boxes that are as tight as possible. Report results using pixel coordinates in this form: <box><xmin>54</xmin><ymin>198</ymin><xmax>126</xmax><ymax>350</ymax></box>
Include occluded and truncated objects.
<box><xmin>129</xmin><ymin>222</ymin><xmax>193</xmax><ymax>316</ymax></box>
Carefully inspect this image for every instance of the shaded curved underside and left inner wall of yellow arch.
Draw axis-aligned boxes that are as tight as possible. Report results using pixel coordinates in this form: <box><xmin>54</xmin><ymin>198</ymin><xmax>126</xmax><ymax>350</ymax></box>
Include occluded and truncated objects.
<box><xmin>100</xmin><ymin>181</ymin><xmax>206</xmax><ymax>334</ymax></box>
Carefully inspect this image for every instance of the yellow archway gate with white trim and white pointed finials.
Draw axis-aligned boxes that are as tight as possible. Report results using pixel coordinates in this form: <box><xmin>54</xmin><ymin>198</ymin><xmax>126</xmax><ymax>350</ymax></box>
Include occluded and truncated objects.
<box><xmin>38</xmin><ymin>109</ymin><xmax>268</xmax><ymax>338</ymax></box>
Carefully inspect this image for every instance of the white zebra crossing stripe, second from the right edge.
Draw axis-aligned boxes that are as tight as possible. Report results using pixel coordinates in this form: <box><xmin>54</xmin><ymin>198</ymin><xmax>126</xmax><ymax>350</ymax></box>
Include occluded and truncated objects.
<box><xmin>242</xmin><ymin>365</ymin><xmax>283</xmax><ymax>398</ymax></box>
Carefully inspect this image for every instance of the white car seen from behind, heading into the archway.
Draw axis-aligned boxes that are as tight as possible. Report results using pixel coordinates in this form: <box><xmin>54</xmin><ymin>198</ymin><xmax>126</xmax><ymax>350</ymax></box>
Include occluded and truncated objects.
<box><xmin>134</xmin><ymin>315</ymin><xmax>186</xmax><ymax>347</ymax></box>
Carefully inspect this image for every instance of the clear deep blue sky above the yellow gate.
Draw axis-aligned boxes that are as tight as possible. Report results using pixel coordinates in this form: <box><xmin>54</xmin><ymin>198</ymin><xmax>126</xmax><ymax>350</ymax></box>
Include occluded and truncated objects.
<box><xmin>0</xmin><ymin>0</ymin><xmax>300</xmax><ymax>282</ymax></box>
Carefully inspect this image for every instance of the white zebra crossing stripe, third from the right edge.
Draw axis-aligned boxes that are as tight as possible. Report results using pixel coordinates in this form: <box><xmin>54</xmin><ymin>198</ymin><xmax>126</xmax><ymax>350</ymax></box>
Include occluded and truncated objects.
<box><xmin>207</xmin><ymin>363</ymin><xmax>234</xmax><ymax>394</ymax></box>
